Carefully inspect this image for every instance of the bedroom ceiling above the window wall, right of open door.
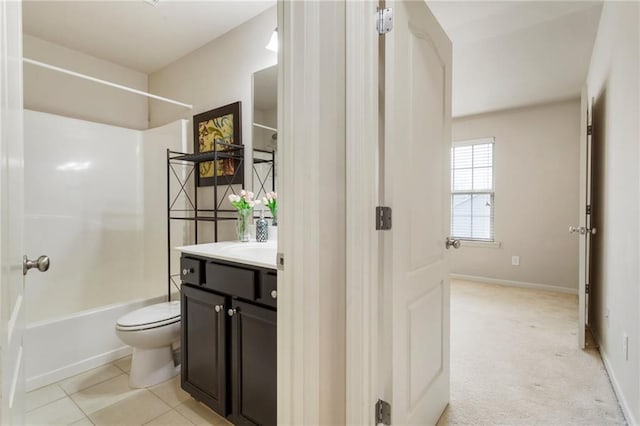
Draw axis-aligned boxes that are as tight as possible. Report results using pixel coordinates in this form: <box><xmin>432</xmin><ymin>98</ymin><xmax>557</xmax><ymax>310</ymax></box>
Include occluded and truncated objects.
<box><xmin>427</xmin><ymin>1</ymin><xmax>602</xmax><ymax>117</ymax></box>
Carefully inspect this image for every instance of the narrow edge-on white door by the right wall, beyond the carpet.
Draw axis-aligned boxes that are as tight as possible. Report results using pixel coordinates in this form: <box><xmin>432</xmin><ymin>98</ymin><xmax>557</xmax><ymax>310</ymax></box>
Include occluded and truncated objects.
<box><xmin>569</xmin><ymin>85</ymin><xmax>596</xmax><ymax>349</ymax></box>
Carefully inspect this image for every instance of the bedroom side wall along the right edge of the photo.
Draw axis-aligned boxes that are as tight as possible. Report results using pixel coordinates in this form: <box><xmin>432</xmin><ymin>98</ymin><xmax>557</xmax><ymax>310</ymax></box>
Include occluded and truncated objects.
<box><xmin>587</xmin><ymin>2</ymin><xmax>640</xmax><ymax>424</ymax></box>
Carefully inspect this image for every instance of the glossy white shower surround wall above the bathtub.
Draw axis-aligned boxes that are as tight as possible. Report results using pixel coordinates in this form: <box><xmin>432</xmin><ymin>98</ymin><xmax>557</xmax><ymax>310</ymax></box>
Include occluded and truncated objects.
<box><xmin>24</xmin><ymin>111</ymin><xmax>186</xmax><ymax>324</ymax></box>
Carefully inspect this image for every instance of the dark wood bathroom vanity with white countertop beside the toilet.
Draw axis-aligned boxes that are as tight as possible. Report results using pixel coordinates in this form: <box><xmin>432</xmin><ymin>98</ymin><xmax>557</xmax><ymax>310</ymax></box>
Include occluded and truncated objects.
<box><xmin>178</xmin><ymin>242</ymin><xmax>277</xmax><ymax>425</ymax></box>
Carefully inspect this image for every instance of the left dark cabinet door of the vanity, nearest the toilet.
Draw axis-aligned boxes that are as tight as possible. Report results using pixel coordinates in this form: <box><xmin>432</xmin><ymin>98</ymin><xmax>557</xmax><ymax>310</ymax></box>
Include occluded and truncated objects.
<box><xmin>181</xmin><ymin>285</ymin><xmax>228</xmax><ymax>416</ymax></box>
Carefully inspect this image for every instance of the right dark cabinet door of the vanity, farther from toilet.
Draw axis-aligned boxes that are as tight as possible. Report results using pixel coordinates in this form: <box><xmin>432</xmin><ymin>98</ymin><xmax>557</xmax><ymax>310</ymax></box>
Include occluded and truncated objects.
<box><xmin>231</xmin><ymin>300</ymin><xmax>277</xmax><ymax>426</ymax></box>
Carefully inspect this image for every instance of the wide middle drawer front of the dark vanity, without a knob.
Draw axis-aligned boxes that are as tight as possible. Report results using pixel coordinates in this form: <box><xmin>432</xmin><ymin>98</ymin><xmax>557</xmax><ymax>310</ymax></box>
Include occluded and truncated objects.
<box><xmin>205</xmin><ymin>262</ymin><xmax>256</xmax><ymax>300</ymax></box>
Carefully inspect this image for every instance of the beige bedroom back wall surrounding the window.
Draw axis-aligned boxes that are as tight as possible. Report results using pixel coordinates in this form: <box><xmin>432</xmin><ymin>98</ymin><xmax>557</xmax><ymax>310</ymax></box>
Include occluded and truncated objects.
<box><xmin>451</xmin><ymin>101</ymin><xmax>580</xmax><ymax>291</ymax></box>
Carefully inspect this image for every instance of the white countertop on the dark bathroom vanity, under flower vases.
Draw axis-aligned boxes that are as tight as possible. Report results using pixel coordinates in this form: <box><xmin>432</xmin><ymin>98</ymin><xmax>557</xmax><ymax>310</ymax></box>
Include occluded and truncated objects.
<box><xmin>176</xmin><ymin>241</ymin><xmax>278</xmax><ymax>269</ymax></box>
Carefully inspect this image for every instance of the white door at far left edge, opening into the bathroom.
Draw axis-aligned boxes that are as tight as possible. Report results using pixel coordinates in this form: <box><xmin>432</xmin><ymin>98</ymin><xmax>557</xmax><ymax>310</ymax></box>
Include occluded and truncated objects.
<box><xmin>0</xmin><ymin>0</ymin><xmax>25</xmax><ymax>425</ymax></box>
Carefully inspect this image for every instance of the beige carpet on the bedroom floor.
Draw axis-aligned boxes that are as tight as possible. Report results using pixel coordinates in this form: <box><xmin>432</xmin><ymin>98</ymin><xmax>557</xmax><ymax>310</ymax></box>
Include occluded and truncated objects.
<box><xmin>438</xmin><ymin>280</ymin><xmax>625</xmax><ymax>426</ymax></box>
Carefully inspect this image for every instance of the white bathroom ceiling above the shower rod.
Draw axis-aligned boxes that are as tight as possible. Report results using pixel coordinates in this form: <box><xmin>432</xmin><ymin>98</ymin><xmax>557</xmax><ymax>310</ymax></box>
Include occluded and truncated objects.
<box><xmin>23</xmin><ymin>0</ymin><xmax>276</xmax><ymax>74</ymax></box>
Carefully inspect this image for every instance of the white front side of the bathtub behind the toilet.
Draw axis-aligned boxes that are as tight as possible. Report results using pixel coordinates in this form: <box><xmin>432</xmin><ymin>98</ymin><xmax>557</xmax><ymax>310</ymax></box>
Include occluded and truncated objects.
<box><xmin>24</xmin><ymin>296</ymin><xmax>166</xmax><ymax>392</ymax></box>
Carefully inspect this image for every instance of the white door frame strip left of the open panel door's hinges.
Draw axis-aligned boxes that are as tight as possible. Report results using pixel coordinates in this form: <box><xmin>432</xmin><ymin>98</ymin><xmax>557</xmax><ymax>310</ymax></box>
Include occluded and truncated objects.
<box><xmin>346</xmin><ymin>1</ymin><xmax>383</xmax><ymax>424</ymax></box>
